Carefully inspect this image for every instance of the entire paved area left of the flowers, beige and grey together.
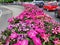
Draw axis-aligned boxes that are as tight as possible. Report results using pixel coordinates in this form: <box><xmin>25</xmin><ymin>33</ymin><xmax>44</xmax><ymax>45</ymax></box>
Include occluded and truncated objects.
<box><xmin>0</xmin><ymin>5</ymin><xmax>24</xmax><ymax>33</ymax></box>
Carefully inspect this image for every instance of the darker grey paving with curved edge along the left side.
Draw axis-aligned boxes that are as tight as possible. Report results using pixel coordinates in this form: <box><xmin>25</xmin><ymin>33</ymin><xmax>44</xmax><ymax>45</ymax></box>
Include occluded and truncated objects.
<box><xmin>0</xmin><ymin>7</ymin><xmax>12</xmax><ymax>33</ymax></box>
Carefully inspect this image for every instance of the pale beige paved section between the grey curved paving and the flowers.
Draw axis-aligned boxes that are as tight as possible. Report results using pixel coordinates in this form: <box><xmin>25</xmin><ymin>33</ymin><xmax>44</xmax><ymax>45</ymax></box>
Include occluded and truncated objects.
<box><xmin>1</xmin><ymin>5</ymin><xmax>24</xmax><ymax>16</ymax></box>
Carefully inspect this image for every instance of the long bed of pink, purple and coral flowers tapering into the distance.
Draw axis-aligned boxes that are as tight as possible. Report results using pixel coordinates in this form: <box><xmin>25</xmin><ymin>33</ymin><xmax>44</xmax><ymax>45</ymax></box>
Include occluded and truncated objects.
<box><xmin>0</xmin><ymin>4</ymin><xmax>60</xmax><ymax>45</ymax></box>
